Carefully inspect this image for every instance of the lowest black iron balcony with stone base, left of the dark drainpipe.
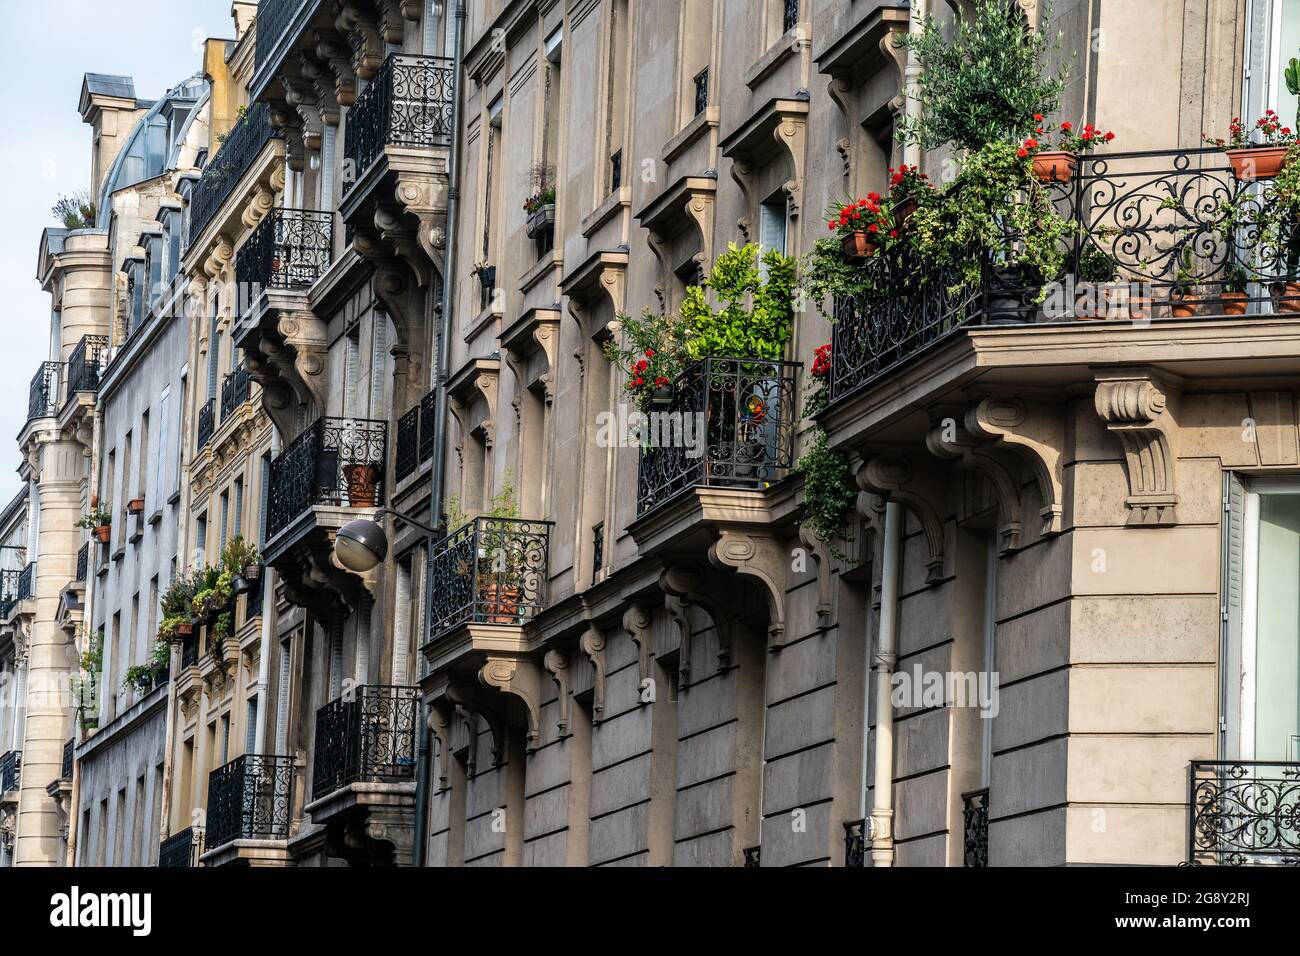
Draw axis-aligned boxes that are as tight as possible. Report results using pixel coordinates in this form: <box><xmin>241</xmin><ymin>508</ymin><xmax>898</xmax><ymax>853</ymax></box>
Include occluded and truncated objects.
<box><xmin>307</xmin><ymin>684</ymin><xmax>417</xmax><ymax>865</ymax></box>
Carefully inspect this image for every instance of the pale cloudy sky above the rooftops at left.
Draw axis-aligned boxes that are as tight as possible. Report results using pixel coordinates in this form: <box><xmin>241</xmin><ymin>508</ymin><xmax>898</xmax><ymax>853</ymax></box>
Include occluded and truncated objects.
<box><xmin>0</xmin><ymin>0</ymin><xmax>234</xmax><ymax>507</ymax></box>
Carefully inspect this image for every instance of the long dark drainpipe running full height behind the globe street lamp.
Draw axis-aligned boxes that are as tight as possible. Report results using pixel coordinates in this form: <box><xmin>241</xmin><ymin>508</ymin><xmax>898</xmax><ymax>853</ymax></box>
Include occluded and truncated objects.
<box><xmin>411</xmin><ymin>0</ymin><xmax>465</xmax><ymax>866</ymax></box>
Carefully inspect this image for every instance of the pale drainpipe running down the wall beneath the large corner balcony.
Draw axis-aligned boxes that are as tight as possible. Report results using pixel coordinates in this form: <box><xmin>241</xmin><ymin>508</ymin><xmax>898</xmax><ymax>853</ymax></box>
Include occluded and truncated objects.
<box><xmin>870</xmin><ymin>501</ymin><xmax>904</xmax><ymax>866</ymax></box>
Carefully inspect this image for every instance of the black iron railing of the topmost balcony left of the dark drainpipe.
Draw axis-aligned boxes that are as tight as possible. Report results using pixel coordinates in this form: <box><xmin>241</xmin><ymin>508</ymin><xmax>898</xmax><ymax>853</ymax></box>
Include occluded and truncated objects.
<box><xmin>343</xmin><ymin>53</ymin><xmax>455</xmax><ymax>191</ymax></box>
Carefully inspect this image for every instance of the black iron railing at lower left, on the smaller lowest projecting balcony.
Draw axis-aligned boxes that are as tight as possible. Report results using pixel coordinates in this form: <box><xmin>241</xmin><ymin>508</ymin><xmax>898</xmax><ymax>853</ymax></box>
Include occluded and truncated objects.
<box><xmin>205</xmin><ymin>753</ymin><xmax>294</xmax><ymax>849</ymax></box>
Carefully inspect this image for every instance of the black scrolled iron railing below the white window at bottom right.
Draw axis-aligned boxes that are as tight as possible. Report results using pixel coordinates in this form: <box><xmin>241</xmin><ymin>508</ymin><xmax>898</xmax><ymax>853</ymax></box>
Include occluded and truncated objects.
<box><xmin>1187</xmin><ymin>760</ymin><xmax>1300</xmax><ymax>866</ymax></box>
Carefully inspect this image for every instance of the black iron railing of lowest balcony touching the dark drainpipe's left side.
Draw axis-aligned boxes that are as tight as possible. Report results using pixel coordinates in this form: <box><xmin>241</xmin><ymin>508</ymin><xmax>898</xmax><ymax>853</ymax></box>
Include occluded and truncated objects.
<box><xmin>312</xmin><ymin>684</ymin><xmax>416</xmax><ymax>800</ymax></box>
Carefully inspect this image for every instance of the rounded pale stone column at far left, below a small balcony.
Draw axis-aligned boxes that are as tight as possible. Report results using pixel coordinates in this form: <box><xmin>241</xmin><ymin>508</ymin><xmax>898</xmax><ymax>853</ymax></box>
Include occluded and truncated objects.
<box><xmin>14</xmin><ymin>438</ymin><xmax>86</xmax><ymax>866</ymax></box>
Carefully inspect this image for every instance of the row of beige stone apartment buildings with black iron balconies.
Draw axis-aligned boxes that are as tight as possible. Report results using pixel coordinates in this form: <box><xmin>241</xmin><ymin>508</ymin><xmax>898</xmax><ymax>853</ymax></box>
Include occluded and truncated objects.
<box><xmin>0</xmin><ymin>0</ymin><xmax>1300</xmax><ymax>866</ymax></box>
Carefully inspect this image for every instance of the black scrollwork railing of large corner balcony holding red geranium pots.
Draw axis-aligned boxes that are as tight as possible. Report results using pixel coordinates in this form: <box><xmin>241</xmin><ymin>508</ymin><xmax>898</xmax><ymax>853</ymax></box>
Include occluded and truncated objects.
<box><xmin>829</xmin><ymin>150</ymin><xmax>1300</xmax><ymax>403</ymax></box>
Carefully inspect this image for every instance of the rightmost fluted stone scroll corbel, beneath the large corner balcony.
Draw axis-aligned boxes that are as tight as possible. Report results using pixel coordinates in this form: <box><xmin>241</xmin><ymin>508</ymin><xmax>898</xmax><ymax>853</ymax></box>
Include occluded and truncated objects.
<box><xmin>1095</xmin><ymin>368</ymin><xmax>1178</xmax><ymax>527</ymax></box>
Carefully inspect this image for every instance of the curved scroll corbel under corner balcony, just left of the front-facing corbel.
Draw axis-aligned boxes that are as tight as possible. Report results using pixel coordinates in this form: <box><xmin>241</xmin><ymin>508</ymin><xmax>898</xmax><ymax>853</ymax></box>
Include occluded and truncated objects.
<box><xmin>966</xmin><ymin>397</ymin><xmax>1065</xmax><ymax>536</ymax></box>
